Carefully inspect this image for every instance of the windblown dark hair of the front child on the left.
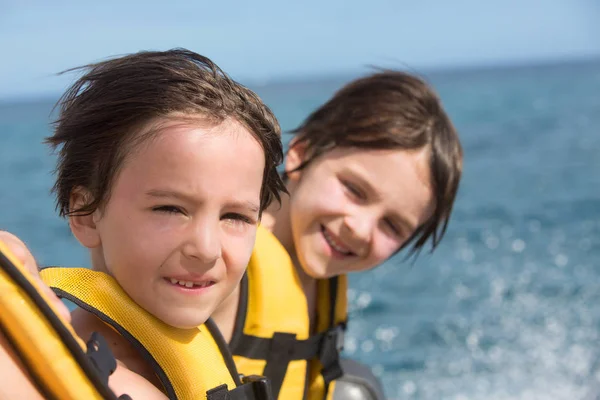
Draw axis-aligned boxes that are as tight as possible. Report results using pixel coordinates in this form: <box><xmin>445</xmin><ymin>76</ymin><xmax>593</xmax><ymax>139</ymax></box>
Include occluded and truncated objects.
<box><xmin>46</xmin><ymin>49</ymin><xmax>285</xmax><ymax>216</ymax></box>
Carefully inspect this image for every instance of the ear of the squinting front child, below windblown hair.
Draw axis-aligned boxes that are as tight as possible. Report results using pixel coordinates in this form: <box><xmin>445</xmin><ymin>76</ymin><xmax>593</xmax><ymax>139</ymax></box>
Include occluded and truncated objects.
<box><xmin>69</xmin><ymin>187</ymin><xmax>101</xmax><ymax>249</ymax></box>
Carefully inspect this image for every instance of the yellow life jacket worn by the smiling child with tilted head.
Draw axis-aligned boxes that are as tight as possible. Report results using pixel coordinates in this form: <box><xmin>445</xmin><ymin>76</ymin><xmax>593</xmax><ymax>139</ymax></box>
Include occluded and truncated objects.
<box><xmin>229</xmin><ymin>227</ymin><xmax>347</xmax><ymax>400</ymax></box>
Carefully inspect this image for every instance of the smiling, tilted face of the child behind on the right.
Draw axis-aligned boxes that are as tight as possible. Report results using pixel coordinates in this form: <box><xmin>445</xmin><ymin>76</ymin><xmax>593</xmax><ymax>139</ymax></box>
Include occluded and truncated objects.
<box><xmin>286</xmin><ymin>146</ymin><xmax>433</xmax><ymax>278</ymax></box>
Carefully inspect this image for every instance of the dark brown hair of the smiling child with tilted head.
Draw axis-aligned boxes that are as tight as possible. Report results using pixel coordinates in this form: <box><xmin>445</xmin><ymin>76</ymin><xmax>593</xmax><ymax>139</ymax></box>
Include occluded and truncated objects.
<box><xmin>287</xmin><ymin>70</ymin><xmax>462</xmax><ymax>254</ymax></box>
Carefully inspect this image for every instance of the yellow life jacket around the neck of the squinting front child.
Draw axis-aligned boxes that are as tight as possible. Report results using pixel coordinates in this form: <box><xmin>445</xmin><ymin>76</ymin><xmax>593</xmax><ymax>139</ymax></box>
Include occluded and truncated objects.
<box><xmin>41</xmin><ymin>267</ymin><xmax>270</xmax><ymax>400</ymax></box>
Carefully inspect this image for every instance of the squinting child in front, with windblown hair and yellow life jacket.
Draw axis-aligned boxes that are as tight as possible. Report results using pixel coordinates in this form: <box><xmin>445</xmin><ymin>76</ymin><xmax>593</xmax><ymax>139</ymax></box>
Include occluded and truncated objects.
<box><xmin>0</xmin><ymin>50</ymin><xmax>285</xmax><ymax>398</ymax></box>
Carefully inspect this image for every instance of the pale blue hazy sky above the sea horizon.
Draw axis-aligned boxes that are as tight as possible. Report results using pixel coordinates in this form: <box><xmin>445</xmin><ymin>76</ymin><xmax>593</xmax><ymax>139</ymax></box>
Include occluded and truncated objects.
<box><xmin>0</xmin><ymin>0</ymin><xmax>600</xmax><ymax>99</ymax></box>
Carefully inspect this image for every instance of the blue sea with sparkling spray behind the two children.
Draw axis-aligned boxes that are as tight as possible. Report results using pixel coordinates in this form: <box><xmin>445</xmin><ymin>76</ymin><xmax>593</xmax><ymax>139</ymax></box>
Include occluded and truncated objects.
<box><xmin>0</xmin><ymin>61</ymin><xmax>600</xmax><ymax>400</ymax></box>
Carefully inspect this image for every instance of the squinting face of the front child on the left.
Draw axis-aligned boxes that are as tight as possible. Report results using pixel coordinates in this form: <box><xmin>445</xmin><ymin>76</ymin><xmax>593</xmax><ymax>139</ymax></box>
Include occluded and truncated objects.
<box><xmin>80</xmin><ymin>120</ymin><xmax>265</xmax><ymax>328</ymax></box>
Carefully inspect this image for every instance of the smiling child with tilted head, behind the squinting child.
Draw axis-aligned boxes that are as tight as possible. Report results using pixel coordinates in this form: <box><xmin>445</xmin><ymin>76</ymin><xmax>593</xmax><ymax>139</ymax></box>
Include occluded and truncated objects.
<box><xmin>225</xmin><ymin>71</ymin><xmax>462</xmax><ymax>400</ymax></box>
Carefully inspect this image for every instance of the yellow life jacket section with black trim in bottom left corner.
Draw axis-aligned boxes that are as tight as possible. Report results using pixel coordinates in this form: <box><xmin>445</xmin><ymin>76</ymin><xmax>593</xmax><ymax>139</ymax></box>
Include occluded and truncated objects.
<box><xmin>0</xmin><ymin>242</ymin><xmax>125</xmax><ymax>400</ymax></box>
